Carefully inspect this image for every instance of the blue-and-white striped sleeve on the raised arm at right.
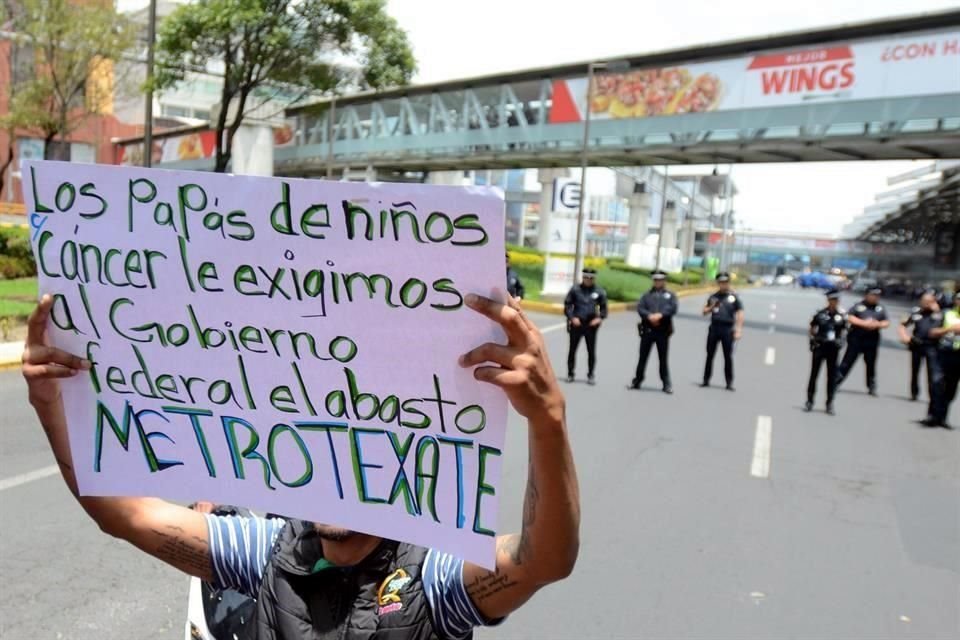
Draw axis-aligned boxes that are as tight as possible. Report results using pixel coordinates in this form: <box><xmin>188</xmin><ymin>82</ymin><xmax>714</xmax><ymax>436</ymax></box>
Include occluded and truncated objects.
<box><xmin>422</xmin><ymin>549</ymin><xmax>503</xmax><ymax>640</ymax></box>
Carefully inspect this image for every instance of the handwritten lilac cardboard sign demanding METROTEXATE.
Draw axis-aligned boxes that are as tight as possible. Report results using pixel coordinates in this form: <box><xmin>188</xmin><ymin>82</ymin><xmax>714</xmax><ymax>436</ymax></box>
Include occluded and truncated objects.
<box><xmin>25</xmin><ymin>162</ymin><xmax>506</xmax><ymax>567</ymax></box>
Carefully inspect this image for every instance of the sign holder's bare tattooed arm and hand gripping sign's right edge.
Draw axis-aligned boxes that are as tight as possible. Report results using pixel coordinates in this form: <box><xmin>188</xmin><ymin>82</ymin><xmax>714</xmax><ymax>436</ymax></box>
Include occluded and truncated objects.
<box><xmin>461</xmin><ymin>297</ymin><xmax>580</xmax><ymax>618</ymax></box>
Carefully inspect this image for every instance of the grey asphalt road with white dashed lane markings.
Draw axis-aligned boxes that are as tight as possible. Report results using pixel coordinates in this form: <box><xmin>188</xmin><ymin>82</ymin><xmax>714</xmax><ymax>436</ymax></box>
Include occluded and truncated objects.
<box><xmin>0</xmin><ymin>289</ymin><xmax>960</xmax><ymax>640</ymax></box>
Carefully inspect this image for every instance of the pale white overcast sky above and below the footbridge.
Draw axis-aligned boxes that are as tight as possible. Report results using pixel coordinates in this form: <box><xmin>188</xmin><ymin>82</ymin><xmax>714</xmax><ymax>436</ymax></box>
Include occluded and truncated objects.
<box><xmin>119</xmin><ymin>0</ymin><xmax>957</xmax><ymax>234</ymax></box>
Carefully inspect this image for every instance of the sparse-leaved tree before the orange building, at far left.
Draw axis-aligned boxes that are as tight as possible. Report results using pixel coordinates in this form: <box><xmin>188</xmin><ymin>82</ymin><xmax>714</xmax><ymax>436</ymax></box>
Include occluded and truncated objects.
<box><xmin>5</xmin><ymin>0</ymin><xmax>137</xmax><ymax>158</ymax></box>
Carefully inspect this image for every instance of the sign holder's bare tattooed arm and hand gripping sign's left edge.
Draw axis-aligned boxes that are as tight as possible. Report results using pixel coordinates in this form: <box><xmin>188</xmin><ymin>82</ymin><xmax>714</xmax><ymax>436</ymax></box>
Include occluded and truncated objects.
<box><xmin>23</xmin><ymin>296</ymin><xmax>213</xmax><ymax>581</ymax></box>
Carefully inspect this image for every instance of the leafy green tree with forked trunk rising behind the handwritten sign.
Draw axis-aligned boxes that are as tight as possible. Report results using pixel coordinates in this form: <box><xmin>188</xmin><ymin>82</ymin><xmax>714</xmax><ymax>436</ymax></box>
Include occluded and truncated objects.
<box><xmin>155</xmin><ymin>0</ymin><xmax>415</xmax><ymax>172</ymax></box>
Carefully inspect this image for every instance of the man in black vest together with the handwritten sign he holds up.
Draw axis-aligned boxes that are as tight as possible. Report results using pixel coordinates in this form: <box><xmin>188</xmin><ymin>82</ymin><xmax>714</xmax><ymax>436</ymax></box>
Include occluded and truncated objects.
<box><xmin>23</xmin><ymin>163</ymin><xmax>580</xmax><ymax>639</ymax></box>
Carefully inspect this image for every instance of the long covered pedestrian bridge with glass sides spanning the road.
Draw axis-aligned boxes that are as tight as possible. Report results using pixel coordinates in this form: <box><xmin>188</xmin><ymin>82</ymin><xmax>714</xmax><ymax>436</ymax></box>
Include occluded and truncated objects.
<box><xmin>133</xmin><ymin>11</ymin><xmax>960</xmax><ymax>176</ymax></box>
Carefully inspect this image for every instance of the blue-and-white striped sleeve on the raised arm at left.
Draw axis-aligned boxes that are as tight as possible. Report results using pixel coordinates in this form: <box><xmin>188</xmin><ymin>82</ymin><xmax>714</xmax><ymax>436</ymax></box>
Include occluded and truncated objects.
<box><xmin>207</xmin><ymin>515</ymin><xmax>286</xmax><ymax>598</ymax></box>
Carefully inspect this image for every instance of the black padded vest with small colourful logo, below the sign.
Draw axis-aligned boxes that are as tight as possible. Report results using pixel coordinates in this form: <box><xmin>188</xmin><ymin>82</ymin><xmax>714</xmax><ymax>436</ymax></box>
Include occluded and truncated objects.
<box><xmin>253</xmin><ymin>520</ymin><xmax>439</xmax><ymax>640</ymax></box>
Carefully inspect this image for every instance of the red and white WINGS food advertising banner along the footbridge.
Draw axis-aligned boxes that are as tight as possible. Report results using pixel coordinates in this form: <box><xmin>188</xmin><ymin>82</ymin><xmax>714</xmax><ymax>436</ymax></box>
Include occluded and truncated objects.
<box><xmin>548</xmin><ymin>30</ymin><xmax>960</xmax><ymax>124</ymax></box>
